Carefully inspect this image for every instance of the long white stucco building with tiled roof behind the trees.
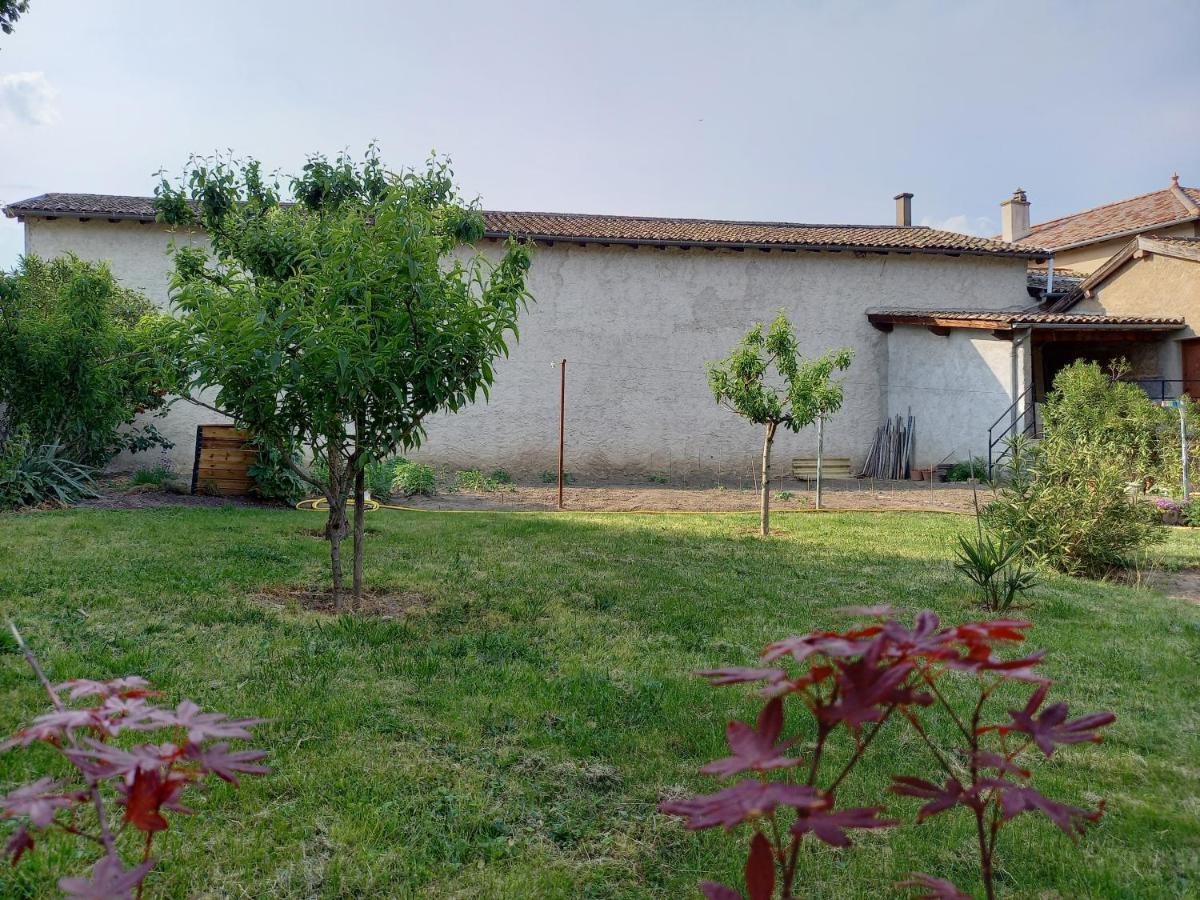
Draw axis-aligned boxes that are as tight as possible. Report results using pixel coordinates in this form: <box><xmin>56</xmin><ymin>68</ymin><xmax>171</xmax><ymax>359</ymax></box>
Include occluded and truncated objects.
<box><xmin>5</xmin><ymin>193</ymin><xmax>1180</xmax><ymax>481</ymax></box>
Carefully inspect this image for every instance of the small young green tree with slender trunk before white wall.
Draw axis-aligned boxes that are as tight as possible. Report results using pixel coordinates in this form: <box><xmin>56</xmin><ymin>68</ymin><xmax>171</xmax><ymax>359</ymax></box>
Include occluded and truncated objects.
<box><xmin>707</xmin><ymin>312</ymin><xmax>854</xmax><ymax>535</ymax></box>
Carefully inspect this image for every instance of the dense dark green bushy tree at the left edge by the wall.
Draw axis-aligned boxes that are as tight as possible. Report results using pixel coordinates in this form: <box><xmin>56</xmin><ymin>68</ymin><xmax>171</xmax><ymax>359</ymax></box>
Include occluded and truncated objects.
<box><xmin>0</xmin><ymin>256</ymin><xmax>175</xmax><ymax>467</ymax></box>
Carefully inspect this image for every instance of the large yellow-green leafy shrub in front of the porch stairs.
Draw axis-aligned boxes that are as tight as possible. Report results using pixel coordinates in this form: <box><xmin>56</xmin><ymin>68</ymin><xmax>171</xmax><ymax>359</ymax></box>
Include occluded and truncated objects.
<box><xmin>984</xmin><ymin>362</ymin><xmax>1163</xmax><ymax>575</ymax></box>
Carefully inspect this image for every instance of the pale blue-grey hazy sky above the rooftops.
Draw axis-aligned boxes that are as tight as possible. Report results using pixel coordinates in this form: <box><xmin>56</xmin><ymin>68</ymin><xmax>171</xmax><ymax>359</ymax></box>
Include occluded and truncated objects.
<box><xmin>0</xmin><ymin>0</ymin><xmax>1200</xmax><ymax>268</ymax></box>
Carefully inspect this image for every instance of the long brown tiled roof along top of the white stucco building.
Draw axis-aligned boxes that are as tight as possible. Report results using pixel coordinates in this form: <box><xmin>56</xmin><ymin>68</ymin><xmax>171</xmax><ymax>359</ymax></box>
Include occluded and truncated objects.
<box><xmin>5</xmin><ymin>193</ymin><xmax>1049</xmax><ymax>260</ymax></box>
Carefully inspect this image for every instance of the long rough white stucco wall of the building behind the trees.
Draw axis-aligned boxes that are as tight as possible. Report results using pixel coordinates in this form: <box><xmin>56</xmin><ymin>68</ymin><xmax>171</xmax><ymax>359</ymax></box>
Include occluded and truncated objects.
<box><xmin>18</xmin><ymin>218</ymin><xmax>1026</xmax><ymax>481</ymax></box>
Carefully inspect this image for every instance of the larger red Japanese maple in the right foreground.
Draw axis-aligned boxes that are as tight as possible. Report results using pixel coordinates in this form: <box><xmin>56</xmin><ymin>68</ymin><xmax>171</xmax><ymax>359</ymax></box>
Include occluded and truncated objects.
<box><xmin>660</xmin><ymin>606</ymin><xmax>1115</xmax><ymax>900</ymax></box>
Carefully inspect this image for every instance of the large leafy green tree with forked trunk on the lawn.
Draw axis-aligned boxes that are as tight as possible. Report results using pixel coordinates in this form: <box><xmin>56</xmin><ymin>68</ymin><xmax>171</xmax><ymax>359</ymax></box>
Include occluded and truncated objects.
<box><xmin>156</xmin><ymin>148</ymin><xmax>530</xmax><ymax>606</ymax></box>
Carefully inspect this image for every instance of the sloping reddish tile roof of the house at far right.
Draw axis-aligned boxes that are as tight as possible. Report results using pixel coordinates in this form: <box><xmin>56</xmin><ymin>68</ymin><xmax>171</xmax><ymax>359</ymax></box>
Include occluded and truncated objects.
<box><xmin>1016</xmin><ymin>185</ymin><xmax>1200</xmax><ymax>250</ymax></box>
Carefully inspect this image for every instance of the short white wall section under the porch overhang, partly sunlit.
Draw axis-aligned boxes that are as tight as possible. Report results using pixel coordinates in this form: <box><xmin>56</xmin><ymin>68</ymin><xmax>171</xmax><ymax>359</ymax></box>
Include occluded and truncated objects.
<box><xmin>888</xmin><ymin>325</ymin><xmax>1031</xmax><ymax>467</ymax></box>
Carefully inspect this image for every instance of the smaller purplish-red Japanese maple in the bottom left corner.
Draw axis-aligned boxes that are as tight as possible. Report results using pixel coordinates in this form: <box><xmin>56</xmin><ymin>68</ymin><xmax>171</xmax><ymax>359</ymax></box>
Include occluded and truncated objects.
<box><xmin>0</xmin><ymin>625</ymin><xmax>269</xmax><ymax>900</ymax></box>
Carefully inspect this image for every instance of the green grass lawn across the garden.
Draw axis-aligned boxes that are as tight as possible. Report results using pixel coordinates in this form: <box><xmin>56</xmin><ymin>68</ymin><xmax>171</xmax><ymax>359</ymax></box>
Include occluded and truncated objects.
<box><xmin>0</xmin><ymin>506</ymin><xmax>1200</xmax><ymax>898</ymax></box>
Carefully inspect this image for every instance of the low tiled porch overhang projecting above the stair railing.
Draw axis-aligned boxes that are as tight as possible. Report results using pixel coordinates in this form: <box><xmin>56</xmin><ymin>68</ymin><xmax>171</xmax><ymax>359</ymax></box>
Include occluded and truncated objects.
<box><xmin>866</xmin><ymin>307</ymin><xmax>1184</xmax><ymax>343</ymax></box>
